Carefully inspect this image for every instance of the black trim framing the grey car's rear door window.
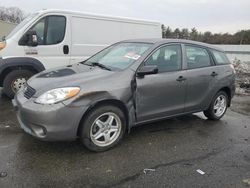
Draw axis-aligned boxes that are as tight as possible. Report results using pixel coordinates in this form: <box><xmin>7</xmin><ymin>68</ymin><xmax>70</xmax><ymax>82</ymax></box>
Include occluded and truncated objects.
<box><xmin>183</xmin><ymin>43</ymin><xmax>215</xmax><ymax>70</ymax></box>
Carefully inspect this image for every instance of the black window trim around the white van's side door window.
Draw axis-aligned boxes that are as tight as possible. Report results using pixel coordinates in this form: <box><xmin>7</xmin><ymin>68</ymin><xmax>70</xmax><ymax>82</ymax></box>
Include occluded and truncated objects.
<box><xmin>19</xmin><ymin>14</ymin><xmax>67</xmax><ymax>46</ymax></box>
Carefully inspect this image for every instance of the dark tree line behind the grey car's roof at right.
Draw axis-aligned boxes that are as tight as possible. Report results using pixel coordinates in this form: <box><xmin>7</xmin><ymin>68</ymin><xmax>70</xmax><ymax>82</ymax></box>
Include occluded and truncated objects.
<box><xmin>162</xmin><ymin>25</ymin><xmax>250</xmax><ymax>44</ymax></box>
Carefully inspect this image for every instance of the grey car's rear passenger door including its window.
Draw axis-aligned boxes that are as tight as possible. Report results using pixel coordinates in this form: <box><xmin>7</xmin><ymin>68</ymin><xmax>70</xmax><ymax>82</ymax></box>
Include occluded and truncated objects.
<box><xmin>184</xmin><ymin>45</ymin><xmax>218</xmax><ymax>112</ymax></box>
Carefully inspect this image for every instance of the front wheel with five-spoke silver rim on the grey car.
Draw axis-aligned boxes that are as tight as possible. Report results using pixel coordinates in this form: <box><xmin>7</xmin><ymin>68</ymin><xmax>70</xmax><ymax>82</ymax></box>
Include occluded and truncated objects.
<box><xmin>80</xmin><ymin>105</ymin><xmax>126</xmax><ymax>152</ymax></box>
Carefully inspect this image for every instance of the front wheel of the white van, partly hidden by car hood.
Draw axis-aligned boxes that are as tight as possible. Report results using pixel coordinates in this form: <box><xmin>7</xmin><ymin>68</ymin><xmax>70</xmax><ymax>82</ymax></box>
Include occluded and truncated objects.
<box><xmin>3</xmin><ymin>70</ymin><xmax>34</xmax><ymax>98</ymax></box>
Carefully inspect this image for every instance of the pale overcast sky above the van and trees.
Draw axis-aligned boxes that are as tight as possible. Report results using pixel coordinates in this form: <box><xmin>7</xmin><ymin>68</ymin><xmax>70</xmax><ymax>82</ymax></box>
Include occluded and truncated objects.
<box><xmin>0</xmin><ymin>0</ymin><xmax>250</xmax><ymax>33</ymax></box>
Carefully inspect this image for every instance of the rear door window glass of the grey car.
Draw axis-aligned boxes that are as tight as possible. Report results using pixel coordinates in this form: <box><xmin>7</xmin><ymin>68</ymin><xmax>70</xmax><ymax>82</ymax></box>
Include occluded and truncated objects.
<box><xmin>185</xmin><ymin>45</ymin><xmax>211</xmax><ymax>69</ymax></box>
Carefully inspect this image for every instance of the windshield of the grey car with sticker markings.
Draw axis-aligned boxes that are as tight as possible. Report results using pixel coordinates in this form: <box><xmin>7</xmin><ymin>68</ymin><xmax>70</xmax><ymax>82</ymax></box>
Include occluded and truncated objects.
<box><xmin>85</xmin><ymin>43</ymin><xmax>152</xmax><ymax>71</ymax></box>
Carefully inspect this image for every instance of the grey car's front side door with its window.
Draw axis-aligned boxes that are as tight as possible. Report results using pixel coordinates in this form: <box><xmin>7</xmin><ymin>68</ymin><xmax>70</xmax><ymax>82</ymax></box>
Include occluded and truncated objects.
<box><xmin>136</xmin><ymin>44</ymin><xmax>186</xmax><ymax>122</ymax></box>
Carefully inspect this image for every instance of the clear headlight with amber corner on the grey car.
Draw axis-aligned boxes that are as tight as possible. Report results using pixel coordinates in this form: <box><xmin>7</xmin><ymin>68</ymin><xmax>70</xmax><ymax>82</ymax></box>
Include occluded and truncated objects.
<box><xmin>35</xmin><ymin>87</ymin><xmax>80</xmax><ymax>104</ymax></box>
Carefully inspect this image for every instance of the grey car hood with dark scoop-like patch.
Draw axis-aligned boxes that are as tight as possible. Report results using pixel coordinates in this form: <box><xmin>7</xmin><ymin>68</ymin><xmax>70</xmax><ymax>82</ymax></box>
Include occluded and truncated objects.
<box><xmin>27</xmin><ymin>63</ymin><xmax>116</xmax><ymax>97</ymax></box>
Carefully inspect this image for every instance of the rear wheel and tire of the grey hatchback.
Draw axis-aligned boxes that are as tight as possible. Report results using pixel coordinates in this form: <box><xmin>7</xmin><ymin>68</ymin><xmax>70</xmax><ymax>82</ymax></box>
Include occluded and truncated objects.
<box><xmin>203</xmin><ymin>91</ymin><xmax>229</xmax><ymax>120</ymax></box>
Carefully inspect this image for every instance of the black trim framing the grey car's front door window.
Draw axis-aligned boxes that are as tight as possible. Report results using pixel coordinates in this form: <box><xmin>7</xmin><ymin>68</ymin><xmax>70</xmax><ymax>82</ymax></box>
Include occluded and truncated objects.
<box><xmin>141</xmin><ymin>42</ymin><xmax>184</xmax><ymax>74</ymax></box>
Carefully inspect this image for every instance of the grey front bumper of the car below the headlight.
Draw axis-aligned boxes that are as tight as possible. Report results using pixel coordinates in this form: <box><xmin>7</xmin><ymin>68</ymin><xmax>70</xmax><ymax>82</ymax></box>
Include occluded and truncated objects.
<box><xmin>12</xmin><ymin>92</ymin><xmax>87</xmax><ymax>141</ymax></box>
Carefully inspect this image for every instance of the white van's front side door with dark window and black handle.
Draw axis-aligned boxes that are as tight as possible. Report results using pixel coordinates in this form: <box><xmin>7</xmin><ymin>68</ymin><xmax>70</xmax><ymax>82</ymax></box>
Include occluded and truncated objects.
<box><xmin>24</xmin><ymin>15</ymin><xmax>71</xmax><ymax>69</ymax></box>
